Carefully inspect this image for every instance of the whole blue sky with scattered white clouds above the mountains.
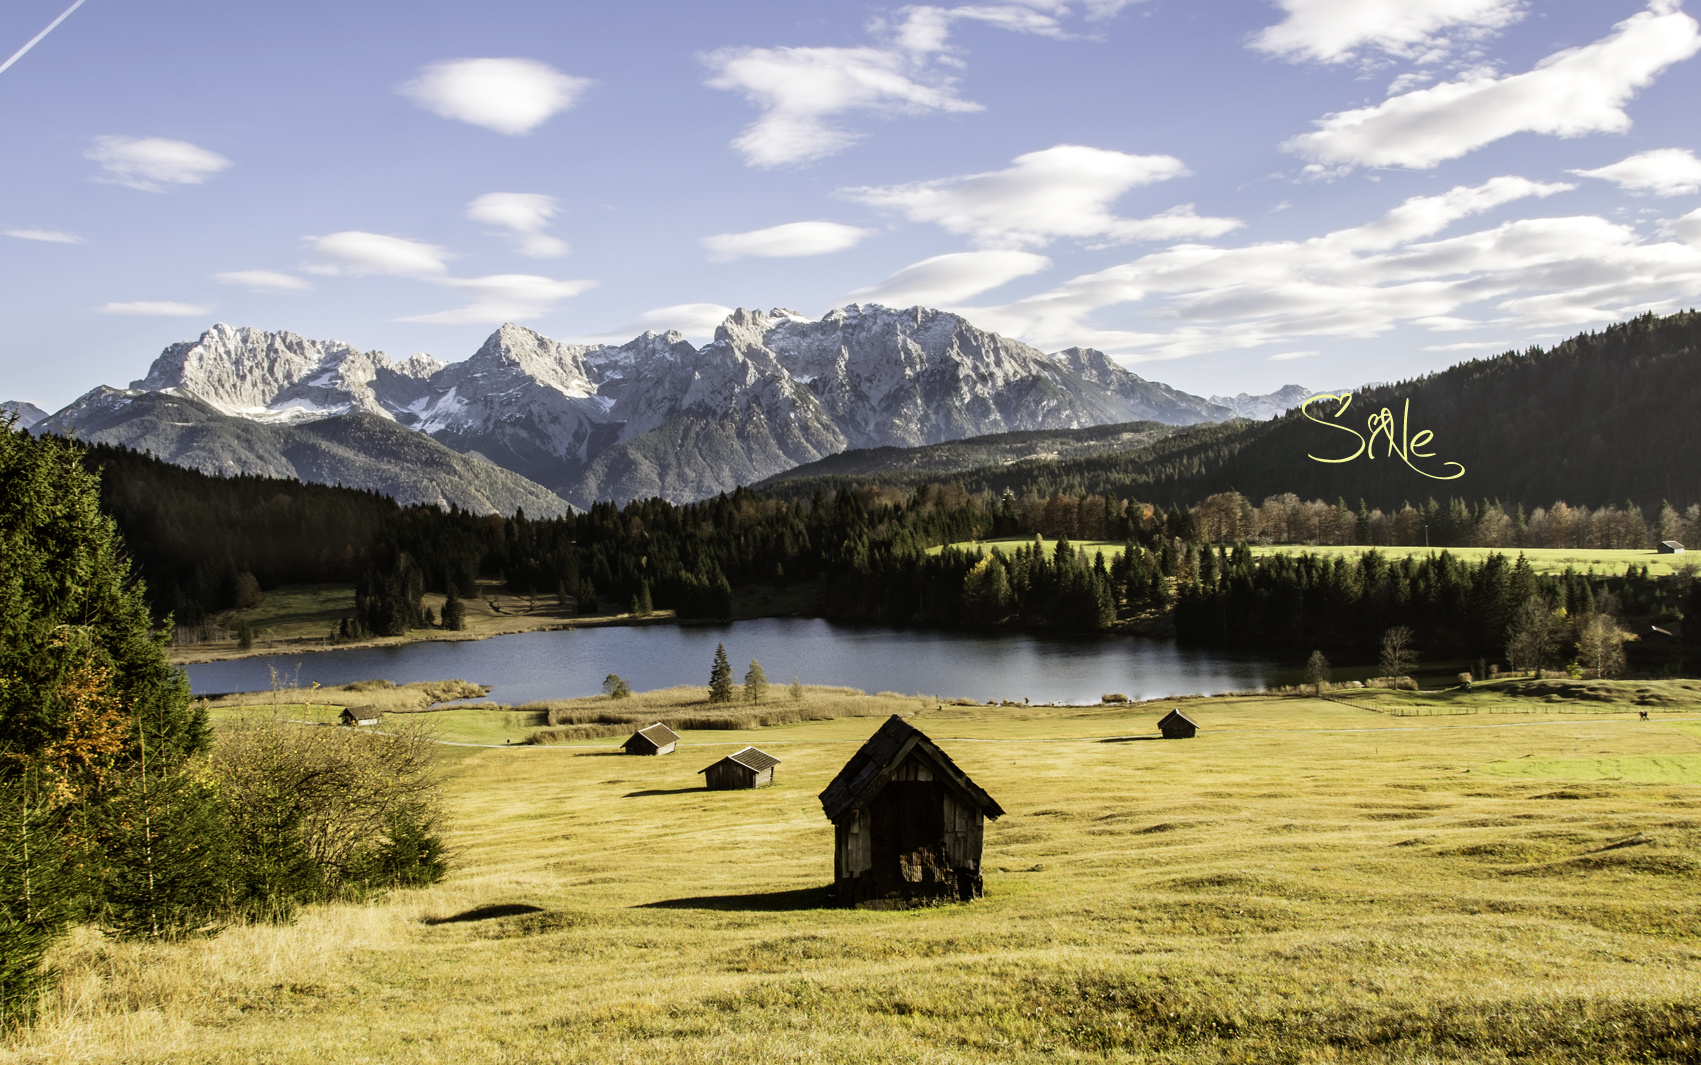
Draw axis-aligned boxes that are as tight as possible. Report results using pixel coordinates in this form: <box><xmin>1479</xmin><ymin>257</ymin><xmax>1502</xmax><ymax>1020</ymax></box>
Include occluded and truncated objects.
<box><xmin>0</xmin><ymin>0</ymin><xmax>1701</xmax><ymax>410</ymax></box>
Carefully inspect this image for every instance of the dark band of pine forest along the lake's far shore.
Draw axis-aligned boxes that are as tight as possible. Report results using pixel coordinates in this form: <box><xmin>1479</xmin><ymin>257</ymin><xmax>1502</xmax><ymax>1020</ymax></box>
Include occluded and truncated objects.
<box><xmin>66</xmin><ymin>433</ymin><xmax>1701</xmax><ymax>677</ymax></box>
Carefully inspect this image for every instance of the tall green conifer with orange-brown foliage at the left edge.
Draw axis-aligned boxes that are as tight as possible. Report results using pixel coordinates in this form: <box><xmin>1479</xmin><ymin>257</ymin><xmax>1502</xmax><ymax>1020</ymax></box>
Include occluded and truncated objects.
<box><xmin>0</xmin><ymin>425</ymin><xmax>209</xmax><ymax>1022</ymax></box>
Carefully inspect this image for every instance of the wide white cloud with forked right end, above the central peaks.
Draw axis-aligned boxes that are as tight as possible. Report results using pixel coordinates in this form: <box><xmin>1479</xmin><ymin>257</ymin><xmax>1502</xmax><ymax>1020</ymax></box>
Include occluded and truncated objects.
<box><xmin>840</xmin><ymin>145</ymin><xmax>1242</xmax><ymax>247</ymax></box>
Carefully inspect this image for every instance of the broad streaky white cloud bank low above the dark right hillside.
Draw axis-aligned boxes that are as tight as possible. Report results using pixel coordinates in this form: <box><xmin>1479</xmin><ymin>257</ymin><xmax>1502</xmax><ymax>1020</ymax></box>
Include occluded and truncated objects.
<box><xmin>961</xmin><ymin>177</ymin><xmax>1701</xmax><ymax>359</ymax></box>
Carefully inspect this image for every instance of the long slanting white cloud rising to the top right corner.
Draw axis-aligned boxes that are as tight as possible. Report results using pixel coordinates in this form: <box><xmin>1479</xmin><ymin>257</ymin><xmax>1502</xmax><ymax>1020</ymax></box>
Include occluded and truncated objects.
<box><xmin>1283</xmin><ymin>0</ymin><xmax>1701</xmax><ymax>174</ymax></box>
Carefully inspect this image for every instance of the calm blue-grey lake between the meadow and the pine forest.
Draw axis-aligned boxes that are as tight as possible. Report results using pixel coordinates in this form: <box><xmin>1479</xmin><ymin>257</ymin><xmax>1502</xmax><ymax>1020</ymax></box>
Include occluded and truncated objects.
<box><xmin>187</xmin><ymin>618</ymin><xmax>1276</xmax><ymax>704</ymax></box>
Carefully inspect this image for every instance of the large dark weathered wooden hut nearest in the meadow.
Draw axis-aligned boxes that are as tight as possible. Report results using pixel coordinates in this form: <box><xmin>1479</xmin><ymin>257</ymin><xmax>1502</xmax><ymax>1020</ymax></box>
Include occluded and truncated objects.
<box><xmin>822</xmin><ymin>715</ymin><xmax>1004</xmax><ymax>908</ymax></box>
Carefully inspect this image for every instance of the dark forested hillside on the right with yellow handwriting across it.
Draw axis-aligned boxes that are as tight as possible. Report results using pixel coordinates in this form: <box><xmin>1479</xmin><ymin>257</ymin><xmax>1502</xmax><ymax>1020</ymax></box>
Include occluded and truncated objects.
<box><xmin>776</xmin><ymin>311</ymin><xmax>1701</xmax><ymax>512</ymax></box>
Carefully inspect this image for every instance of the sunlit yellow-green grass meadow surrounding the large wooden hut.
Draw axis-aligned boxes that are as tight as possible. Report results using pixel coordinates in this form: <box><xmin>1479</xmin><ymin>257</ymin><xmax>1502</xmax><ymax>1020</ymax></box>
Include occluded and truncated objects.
<box><xmin>0</xmin><ymin>686</ymin><xmax>1701</xmax><ymax>1065</ymax></box>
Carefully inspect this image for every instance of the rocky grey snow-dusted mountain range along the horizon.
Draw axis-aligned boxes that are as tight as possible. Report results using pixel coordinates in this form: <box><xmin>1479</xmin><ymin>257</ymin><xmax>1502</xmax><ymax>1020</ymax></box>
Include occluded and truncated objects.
<box><xmin>20</xmin><ymin>305</ymin><xmax>1305</xmax><ymax>514</ymax></box>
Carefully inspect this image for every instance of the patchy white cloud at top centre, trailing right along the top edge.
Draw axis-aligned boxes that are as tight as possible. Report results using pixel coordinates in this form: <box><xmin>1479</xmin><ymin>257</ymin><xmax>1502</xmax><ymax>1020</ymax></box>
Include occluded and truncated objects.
<box><xmin>703</xmin><ymin>0</ymin><xmax>1126</xmax><ymax>167</ymax></box>
